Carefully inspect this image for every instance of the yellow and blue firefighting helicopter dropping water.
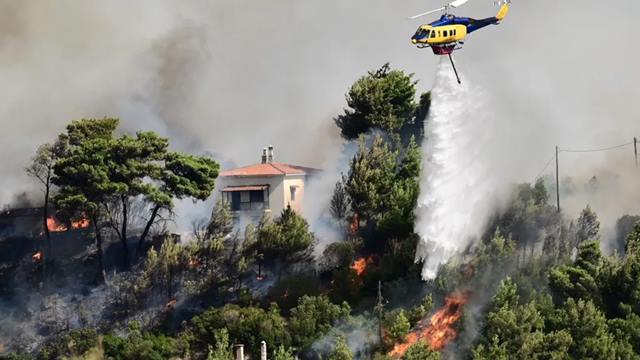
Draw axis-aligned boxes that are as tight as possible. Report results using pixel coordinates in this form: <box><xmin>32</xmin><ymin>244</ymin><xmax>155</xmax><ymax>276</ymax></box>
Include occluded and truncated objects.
<box><xmin>409</xmin><ymin>0</ymin><xmax>511</xmax><ymax>84</ymax></box>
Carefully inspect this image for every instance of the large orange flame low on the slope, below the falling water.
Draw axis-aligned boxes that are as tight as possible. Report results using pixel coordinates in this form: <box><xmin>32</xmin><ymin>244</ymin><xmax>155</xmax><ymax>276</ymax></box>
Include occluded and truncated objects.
<box><xmin>389</xmin><ymin>292</ymin><xmax>470</xmax><ymax>358</ymax></box>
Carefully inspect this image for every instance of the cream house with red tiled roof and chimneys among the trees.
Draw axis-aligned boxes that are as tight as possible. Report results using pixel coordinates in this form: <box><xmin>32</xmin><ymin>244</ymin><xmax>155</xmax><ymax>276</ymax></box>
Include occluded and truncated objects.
<box><xmin>218</xmin><ymin>145</ymin><xmax>319</xmax><ymax>219</ymax></box>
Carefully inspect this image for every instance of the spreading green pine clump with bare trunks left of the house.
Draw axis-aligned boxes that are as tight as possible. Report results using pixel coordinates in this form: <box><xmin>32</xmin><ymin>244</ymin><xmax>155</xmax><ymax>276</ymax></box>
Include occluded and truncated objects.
<box><xmin>52</xmin><ymin>118</ymin><xmax>218</xmax><ymax>280</ymax></box>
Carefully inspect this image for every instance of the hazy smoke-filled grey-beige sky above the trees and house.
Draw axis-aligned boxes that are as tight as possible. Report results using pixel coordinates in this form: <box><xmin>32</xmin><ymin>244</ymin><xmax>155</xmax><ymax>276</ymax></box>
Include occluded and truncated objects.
<box><xmin>0</xmin><ymin>0</ymin><xmax>640</xmax><ymax>217</ymax></box>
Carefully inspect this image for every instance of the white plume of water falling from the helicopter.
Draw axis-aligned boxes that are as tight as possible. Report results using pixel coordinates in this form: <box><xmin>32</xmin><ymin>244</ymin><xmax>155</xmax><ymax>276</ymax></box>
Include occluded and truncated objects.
<box><xmin>416</xmin><ymin>57</ymin><xmax>500</xmax><ymax>279</ymax></box>
